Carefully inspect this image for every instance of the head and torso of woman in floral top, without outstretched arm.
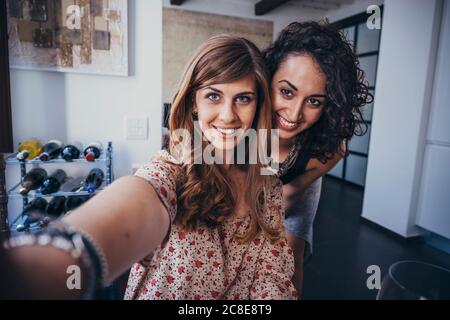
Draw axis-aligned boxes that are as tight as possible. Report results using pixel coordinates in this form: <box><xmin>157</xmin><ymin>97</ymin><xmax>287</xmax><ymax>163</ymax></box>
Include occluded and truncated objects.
<box><xmin>126</xmin><ymin>36</ymin><xmax>295</xmax><ymax>299</ymax></box>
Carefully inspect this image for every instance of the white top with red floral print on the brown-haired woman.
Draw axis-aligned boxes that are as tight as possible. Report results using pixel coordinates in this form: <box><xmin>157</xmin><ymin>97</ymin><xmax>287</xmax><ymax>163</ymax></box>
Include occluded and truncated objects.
<box><xmin>125</xmin><ymin>151</ymin><xmax>297</xmax><ymax>300</ymax></box>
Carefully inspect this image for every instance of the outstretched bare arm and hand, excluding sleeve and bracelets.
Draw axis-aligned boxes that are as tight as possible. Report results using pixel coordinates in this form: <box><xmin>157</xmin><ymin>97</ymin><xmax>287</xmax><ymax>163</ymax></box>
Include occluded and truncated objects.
<box><xmin>1</xmin><ymin>177</ymin><xmax>170</xmax><ymax>299</ymax></box>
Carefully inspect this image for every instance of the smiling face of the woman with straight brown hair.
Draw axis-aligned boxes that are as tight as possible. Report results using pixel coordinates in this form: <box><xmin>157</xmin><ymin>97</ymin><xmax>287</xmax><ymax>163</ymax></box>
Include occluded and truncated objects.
<box><xmin>195</xmin><ymin>76</ymin><xmax>257</xmax><ymax>150</ymax></box>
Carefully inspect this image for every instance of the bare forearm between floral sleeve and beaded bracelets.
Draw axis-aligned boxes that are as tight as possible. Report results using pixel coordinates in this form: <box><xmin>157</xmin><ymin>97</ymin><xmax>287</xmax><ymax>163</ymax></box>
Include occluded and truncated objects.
<box><xmin>64</xmin><ymin>177</ymin><xmax>170</xmax><ymax>280</ymax></box>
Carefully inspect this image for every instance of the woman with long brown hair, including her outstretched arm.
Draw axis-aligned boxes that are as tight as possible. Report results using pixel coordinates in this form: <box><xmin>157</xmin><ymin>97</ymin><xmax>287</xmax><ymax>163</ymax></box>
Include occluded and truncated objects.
<box><xmin>1</xmin><ymin>35</ymin><xmax>297</xmax><ymax>299</ymax></box>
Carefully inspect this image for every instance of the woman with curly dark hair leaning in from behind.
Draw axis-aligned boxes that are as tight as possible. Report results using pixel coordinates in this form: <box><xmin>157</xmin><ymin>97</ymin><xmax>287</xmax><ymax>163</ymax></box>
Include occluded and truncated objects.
<box><xmin>263</xmin><ymin>22</ymin><xmax>372</xmax><ymax>292</ymax></box>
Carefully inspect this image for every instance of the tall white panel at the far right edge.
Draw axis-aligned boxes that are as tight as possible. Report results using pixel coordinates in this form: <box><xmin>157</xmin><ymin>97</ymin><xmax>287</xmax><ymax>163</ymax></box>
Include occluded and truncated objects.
<box><xmin>417</xmin><ymin>1</ymin><xmax>450</xmax><ymax>240</ymax></box>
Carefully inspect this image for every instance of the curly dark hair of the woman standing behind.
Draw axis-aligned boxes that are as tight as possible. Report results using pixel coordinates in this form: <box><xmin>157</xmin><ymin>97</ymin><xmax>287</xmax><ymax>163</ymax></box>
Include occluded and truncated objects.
<box><xmin>263</xmin><ymin>21</ymin><xmax>373</xmax><ymax>163</ymax></box>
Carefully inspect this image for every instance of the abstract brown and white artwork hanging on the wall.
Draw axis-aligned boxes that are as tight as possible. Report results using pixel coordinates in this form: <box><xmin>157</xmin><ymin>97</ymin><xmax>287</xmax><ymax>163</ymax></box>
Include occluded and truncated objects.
<box><xmin>7</xmin><ymin>0</ymin><xmax>128</xmax><ymax>76</ymax></box>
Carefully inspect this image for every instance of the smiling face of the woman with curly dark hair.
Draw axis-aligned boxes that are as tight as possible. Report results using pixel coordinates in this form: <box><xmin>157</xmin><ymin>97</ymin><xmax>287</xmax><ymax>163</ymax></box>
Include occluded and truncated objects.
<box><xmin>271</xmin><ymin>54</ymin><xmax>327</xmax><ymax>142</ymax></box>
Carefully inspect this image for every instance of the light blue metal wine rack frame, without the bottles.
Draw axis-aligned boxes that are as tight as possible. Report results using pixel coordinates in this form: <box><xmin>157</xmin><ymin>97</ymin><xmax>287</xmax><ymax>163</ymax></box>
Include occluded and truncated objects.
<box><xmin>5</xmin><ymin>142</ymin><xmax>113</xmax><ymax>232</ymax></box>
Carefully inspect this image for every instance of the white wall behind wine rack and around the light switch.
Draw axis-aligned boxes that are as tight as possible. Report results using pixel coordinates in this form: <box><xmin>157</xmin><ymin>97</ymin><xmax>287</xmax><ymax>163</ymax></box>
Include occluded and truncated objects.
<box><xmin>6</xmin><ymin>0</ymin><xmax>162</xmax><ymax>220</ymax></box>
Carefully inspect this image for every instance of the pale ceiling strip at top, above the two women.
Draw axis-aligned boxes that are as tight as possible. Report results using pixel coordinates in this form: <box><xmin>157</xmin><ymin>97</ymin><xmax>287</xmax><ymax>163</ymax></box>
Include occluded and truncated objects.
<box><xmin>163</xmin><ymin>0</ymin><xmax>322</xmax><ymax>38</ymax></box>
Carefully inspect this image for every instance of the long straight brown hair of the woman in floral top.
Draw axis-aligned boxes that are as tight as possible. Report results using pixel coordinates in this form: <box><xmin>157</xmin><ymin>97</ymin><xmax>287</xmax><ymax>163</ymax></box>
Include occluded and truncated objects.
<box><xmin>169</xmin><ymin>35</ymin><xmax>282</xmax><ymax>242</ymax></box>
